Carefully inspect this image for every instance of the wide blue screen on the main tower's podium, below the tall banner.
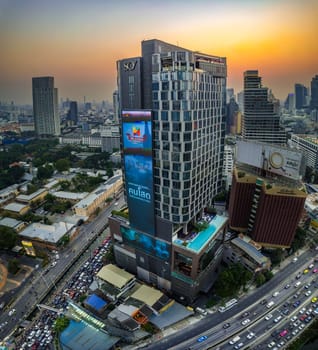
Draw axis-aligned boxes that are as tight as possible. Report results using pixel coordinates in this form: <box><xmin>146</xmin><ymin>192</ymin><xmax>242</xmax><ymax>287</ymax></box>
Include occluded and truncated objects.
<box><xmin>120</xmin><ymin>226</ymin><xmax>170</xmax><ymax>260</ymax></box>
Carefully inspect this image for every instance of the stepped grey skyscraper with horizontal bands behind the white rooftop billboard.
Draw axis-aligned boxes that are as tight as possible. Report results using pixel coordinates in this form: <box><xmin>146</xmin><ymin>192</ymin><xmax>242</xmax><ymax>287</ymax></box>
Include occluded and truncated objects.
<box><xmin>242</xmin><ymin>70</ymin><xmax>286</xmax><ymax>144</ymax></box>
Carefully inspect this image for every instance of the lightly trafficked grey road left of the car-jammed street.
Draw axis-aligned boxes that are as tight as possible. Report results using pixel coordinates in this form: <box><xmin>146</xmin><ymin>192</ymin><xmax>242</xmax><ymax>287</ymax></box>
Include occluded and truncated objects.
<box><xmin>0</xmin><ymin>196</ymin><xmax>124</xmax><ymax>339</ymax></box>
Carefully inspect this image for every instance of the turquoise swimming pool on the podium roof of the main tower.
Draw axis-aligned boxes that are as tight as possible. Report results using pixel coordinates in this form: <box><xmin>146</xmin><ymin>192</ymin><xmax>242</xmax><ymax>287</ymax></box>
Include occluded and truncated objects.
<box><xmin>173</xmin><ymin>215</ymin><xmax>227</xmax><ymax>252</ymax></box>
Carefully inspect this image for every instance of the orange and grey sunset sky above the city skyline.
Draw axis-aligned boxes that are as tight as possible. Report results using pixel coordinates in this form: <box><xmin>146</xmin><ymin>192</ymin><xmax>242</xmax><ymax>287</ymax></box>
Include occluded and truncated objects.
<box><xmin>0</xmin><ymin>0</ymin><xmax>318</xmax><ymax>104</ymax></box>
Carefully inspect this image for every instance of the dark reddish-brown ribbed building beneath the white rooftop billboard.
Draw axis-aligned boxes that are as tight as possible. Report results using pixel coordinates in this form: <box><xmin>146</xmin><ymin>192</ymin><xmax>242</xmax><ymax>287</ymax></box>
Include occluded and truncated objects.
<box><xmin>229</xmin><ymin>168</ymin><xmax>307</xmax><ymax>248</ymax></box>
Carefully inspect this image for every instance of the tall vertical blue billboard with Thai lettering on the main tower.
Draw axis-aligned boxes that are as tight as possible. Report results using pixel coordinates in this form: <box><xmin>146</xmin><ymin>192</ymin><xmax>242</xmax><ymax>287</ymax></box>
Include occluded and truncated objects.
<box><xmin>122</xmin><ymin>111</ymin><xmax>155</xmax><ymax>234</ymax></box>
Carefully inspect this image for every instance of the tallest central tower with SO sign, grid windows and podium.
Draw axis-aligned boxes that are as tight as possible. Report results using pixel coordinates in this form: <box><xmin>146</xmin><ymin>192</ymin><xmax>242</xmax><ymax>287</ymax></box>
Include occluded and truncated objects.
<box><xmin>110</xmin><ymin>40</ymin><xmax>227</xmax><ymax>299</ymax></box>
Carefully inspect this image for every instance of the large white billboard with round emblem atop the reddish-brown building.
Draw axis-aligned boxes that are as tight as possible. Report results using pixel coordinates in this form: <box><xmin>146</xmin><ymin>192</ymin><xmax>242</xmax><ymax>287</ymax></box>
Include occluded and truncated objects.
<box><xmin>236</xmin><ymin>141</ymin><xmax>302</xmax><ymax>180</ymax></box>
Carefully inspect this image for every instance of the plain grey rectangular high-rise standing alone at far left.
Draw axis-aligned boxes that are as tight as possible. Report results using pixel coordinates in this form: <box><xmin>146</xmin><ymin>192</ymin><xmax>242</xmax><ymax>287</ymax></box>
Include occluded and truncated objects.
<box><xmin>32</xmin><ymin>77</ymin><xmax>61</xmax><ymax>137</ymax></box>
